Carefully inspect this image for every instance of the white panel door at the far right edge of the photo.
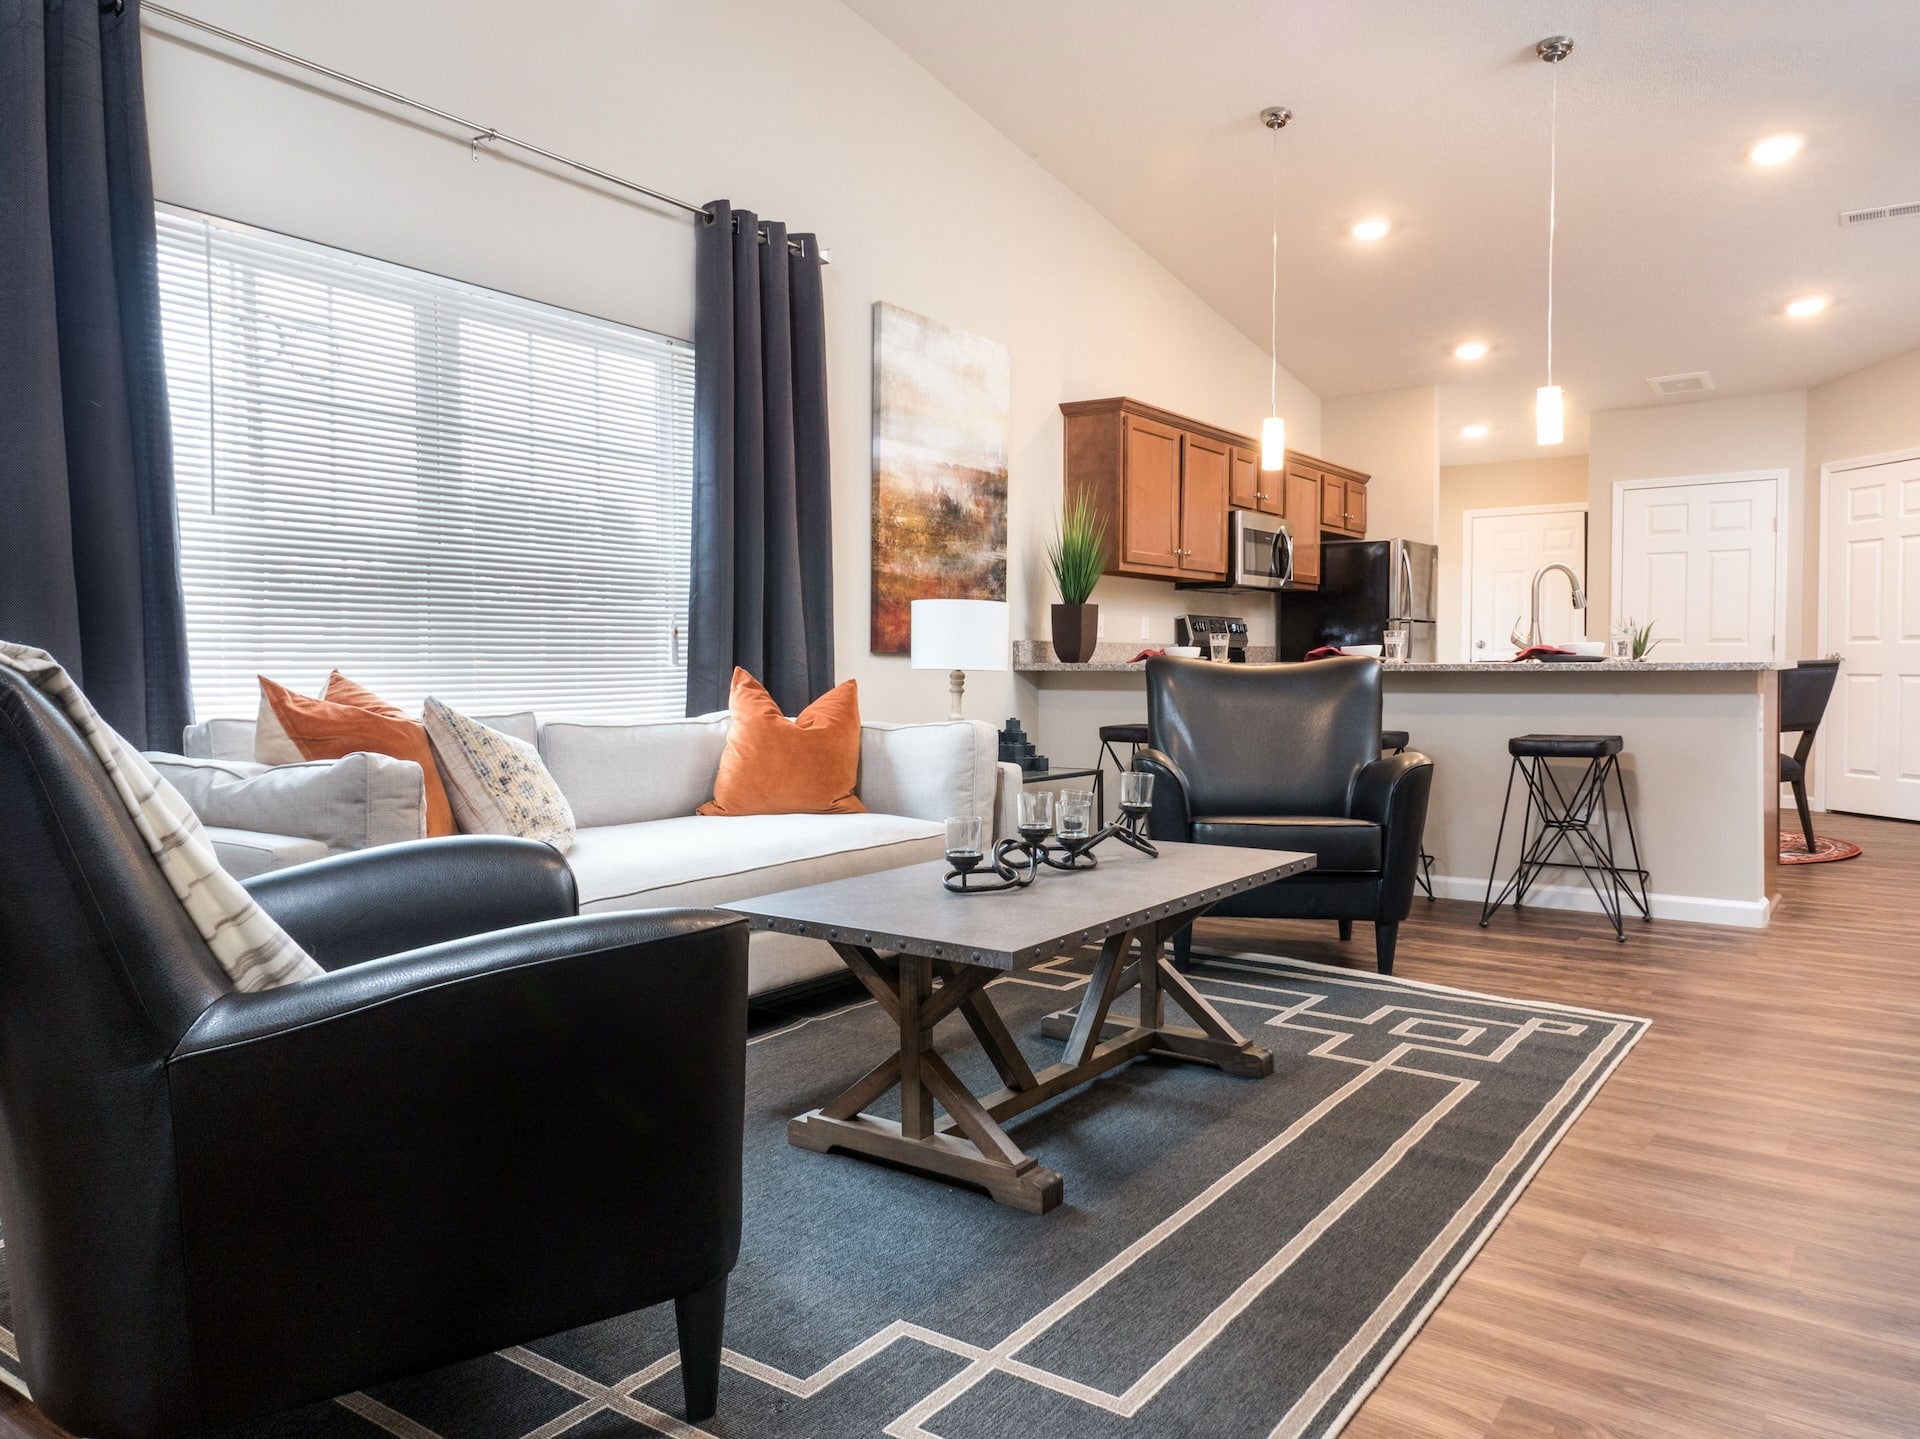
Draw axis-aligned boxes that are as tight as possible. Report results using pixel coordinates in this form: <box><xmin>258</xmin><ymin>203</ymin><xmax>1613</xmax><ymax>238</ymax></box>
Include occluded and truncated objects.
<box><xmin>1820</xmin><ymin>459</ymin><xmax>1920</xmax><ymax>820</ymax></box>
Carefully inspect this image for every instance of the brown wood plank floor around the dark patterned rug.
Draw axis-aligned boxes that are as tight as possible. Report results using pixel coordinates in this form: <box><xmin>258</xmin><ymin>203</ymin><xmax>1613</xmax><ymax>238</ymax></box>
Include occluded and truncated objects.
<box><xmin>0</xmin><ymin>815</ymin><xmax>1920</xmax><ymax>1439</ymax></box>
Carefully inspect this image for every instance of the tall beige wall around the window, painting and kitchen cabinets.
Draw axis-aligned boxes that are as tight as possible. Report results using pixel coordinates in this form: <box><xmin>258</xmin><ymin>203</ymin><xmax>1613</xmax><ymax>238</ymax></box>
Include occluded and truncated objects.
<box><xmin>135</xmin><ymin>0</ymin><xmax>1321</xmax><ymax>724</ymax></box>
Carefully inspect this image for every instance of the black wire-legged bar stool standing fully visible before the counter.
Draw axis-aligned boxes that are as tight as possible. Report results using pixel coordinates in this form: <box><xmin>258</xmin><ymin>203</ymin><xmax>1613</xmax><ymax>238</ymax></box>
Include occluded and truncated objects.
<box><xmin>1480</xmin><ymin>734</ymin><xmax>1653</xmax><ymax>943</ymax></box>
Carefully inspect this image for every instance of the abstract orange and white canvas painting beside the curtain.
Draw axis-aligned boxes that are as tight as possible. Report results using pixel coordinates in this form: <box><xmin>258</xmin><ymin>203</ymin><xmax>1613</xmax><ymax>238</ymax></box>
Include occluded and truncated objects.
<box><xmin>872</xmin><ymin>304</ymin><xmax>1012</xmax><ymax>655</ymax></box>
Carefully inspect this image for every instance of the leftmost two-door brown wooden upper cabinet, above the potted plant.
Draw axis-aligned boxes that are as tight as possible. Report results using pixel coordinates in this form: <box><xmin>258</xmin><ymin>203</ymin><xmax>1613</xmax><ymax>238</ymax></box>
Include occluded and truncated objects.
<box><xmin>1060</xmin><ymin>398</ymin><xmax>1258</xmax><ymax>580</ymax></box>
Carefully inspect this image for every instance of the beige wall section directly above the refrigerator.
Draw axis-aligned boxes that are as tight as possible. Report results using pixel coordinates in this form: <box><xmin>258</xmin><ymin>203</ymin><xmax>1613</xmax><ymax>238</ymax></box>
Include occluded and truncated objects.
<box><xmin>1328</xmin><ymin>384</ymin><xmax>1440</xmax><ymax>540</ymax></box>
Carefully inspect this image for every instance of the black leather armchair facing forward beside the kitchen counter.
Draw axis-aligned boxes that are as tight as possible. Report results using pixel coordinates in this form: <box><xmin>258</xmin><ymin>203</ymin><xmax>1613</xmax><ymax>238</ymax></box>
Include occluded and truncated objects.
<box><xmin>1133</xmin><ymin>659</ymin><xmax>1432</xmax><ymax>974</ymax></box>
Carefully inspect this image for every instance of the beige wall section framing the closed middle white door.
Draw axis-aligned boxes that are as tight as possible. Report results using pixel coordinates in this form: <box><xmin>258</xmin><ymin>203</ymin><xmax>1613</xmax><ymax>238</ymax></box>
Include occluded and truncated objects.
<box><xmin>1586</xmin><ymin>390</ymin><xmax>1807</xmax><ymax>641</ymax></box>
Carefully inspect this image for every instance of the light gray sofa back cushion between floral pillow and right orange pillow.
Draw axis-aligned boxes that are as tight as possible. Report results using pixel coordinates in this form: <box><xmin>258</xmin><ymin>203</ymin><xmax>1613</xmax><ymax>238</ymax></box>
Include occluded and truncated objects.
<box><xmin>540</xmin><ymin>713</ymin><xmax>733</xmax><ymax>830</ymax></box>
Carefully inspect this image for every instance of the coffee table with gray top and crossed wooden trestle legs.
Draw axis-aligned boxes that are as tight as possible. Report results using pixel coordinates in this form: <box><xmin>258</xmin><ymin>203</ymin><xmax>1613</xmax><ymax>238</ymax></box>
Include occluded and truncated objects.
<box><xmin>722</xmin><ymin>841</ymin><xmax>1313</xmax><ymax>1214</ymax></box>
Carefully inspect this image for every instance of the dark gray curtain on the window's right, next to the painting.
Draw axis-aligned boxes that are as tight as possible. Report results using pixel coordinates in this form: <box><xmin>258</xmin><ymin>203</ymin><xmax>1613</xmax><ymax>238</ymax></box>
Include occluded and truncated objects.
<box><xmin>687</xmin><ymin>200</ymin><xmax>833</xmax><ymax>715</ymax></box>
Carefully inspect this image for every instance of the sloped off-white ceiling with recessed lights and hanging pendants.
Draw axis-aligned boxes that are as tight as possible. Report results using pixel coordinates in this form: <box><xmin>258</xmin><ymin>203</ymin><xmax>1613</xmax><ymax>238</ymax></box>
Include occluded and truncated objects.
<box><xmin>849</xmin><ymin>0</ymin><xmax>1920</xmax><ymax>463</ymax></box>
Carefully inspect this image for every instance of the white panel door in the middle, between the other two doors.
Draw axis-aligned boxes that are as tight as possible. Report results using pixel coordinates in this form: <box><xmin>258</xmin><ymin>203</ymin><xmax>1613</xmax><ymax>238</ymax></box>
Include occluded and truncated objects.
<box><xmin>1613</xmin><ymin>475</ymin><xmax>1780</xmax><ymax>659</ymax></box>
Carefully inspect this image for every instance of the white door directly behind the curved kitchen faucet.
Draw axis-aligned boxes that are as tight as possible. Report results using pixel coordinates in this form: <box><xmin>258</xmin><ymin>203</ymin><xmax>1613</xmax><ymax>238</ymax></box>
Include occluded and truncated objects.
<box><xmin>1467</xmin><ymin>505</ymin><xmax>1586</xmax><ymax>659</ymax></box>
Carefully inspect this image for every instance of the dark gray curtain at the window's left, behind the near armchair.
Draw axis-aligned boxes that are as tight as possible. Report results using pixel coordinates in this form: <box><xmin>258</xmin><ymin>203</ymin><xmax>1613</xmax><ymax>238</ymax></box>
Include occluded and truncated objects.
<box><xmin>0</xmin><ymin>0</ymin><xmax>188</xmax><ymax>749</ymax></box>
